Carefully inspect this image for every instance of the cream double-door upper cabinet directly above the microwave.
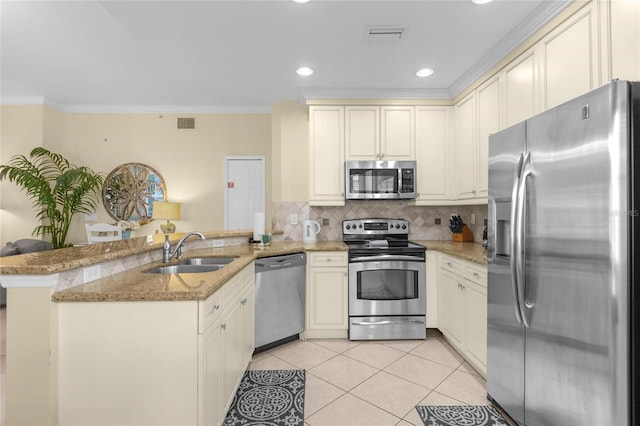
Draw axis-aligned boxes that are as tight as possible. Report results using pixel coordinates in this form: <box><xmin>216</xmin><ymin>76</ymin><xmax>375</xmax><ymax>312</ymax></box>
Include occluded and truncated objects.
<box><xmin>345</xmin><ymin>106</ymin><xmax>415</xmax><ymax>161</ymax></box>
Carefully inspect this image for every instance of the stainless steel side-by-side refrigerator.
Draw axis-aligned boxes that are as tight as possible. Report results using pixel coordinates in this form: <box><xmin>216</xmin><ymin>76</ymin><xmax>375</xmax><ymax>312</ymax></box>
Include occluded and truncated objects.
<box><xmin>487</xmin><ymin>81</ymin><xmax>640</xmax><ymax>426</ymax></box>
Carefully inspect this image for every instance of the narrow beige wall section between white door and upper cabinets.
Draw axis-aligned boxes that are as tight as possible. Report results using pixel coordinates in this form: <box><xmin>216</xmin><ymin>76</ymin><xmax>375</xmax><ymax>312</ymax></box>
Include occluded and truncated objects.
<box><xmin>272</xmin><ymin>102</ymin><xmax>309</xmax><ymax>202</ymax></box>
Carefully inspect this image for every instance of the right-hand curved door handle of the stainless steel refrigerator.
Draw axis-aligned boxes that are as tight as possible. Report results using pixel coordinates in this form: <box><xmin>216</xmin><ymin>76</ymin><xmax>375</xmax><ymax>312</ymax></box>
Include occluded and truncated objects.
<box><xmin>514</xmin><ymin>151</ymin><xmax>533</xmax><ymax>328</ymax></box>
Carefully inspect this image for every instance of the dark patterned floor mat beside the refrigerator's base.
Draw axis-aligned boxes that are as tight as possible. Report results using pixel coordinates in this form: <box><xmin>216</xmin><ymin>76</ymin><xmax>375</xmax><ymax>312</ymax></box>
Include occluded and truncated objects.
<box><xmin>416</xmin><ymin>405</ymin><xmax>509</xmax><ymax>426</ymax></box>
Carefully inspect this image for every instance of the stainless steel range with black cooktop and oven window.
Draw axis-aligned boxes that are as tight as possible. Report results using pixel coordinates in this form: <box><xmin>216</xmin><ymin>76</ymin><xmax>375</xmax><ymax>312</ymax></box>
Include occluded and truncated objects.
<box><xmin>342</xmin><ymin>219</ymin><xmax>426</xmax><ymax>340</ymax></box>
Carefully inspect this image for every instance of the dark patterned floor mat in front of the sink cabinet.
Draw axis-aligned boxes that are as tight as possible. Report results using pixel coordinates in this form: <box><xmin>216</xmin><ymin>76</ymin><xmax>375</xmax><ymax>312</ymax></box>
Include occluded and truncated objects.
<box><xmin>224</xmin><ymin>370</ymin><xmax>305</xmax><ymax>426</ymax></box>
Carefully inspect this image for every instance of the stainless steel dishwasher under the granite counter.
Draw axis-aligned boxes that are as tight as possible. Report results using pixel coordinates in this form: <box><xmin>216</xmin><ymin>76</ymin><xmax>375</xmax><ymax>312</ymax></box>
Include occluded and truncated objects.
<box><xmin>255</xmin><ymin>253</ymin><xmax>307</xmax><ymax>353</ymax></box>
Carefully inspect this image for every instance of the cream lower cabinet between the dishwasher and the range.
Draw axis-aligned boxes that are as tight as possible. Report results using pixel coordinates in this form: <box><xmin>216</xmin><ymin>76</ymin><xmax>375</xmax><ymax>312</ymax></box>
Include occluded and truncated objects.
<box><xmin>305</xmin><ymin>252</ymin><xmax>349</xmax><ymax>338</ymax></box>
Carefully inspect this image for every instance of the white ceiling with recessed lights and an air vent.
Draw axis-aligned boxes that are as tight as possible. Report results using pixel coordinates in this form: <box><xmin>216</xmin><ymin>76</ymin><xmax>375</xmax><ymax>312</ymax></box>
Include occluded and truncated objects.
<box><xmin>0</xmin><ymin>0</ymin><xmax>570</xmax><ymax>112</ymax></box>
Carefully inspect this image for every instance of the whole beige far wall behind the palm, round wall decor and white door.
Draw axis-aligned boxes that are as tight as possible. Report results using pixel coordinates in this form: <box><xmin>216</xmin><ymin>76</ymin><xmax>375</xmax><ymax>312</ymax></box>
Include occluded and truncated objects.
<box><xmin>1</xmin><ymin>106</ymin><xmax>271</xmax><ymax>244</ymax></box>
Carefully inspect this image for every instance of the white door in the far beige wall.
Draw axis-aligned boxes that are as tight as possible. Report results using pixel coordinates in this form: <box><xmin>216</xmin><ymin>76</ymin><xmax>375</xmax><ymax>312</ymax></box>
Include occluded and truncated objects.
<box><xmin>224</xmin><ymin>157</ymin><xmax>266</xmax><ymax>230</ymax></box>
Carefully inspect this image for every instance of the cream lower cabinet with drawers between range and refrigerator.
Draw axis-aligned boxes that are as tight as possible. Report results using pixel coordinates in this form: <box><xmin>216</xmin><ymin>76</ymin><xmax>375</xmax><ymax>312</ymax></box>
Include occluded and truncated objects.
<box><xmin>438</xmin><ymin>254</ymin><xmax>487</xmax><ymax>376</ymax></box>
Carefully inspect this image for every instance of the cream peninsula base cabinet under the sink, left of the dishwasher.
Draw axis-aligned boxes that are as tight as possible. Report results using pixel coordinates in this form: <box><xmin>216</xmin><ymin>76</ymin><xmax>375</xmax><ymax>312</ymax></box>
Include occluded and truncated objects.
<box><xmin>57</xmin><ymin>263</ymin><xmax>254</xmax><ymax>426</ymax></box>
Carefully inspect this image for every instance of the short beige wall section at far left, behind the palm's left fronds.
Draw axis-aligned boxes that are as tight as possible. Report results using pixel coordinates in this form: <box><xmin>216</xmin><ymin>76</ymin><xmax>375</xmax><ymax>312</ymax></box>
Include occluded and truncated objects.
<box><xmin>0</xmin><ymin>105</ymin><xmax>46</xmax><ymax>245</ymax></box>
